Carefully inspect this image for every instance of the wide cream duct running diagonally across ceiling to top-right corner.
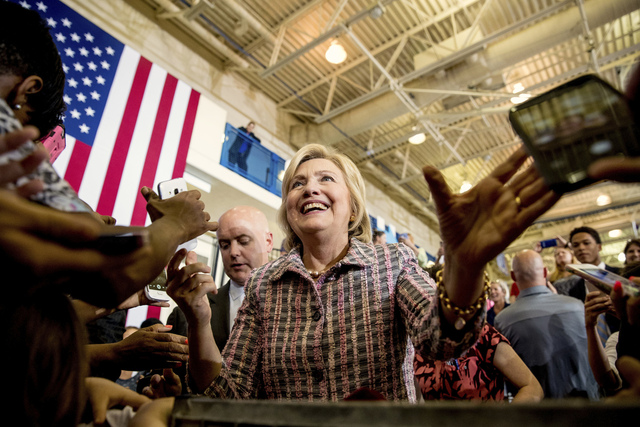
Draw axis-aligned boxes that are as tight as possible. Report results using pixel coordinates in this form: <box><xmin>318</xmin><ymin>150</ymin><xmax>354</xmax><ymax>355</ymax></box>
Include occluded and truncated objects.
<box><xmin>290</xmin><ymin>0</ymin><xmax>638</xmax><ymax>147</ymax></box>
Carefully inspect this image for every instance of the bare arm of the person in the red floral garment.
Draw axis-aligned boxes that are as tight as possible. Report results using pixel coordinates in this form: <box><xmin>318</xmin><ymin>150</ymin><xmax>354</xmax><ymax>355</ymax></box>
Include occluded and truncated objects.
<box><xmin>493</xmin><ymin>342</ymin><xmax>544</xmax><ymax>403</ymax></box>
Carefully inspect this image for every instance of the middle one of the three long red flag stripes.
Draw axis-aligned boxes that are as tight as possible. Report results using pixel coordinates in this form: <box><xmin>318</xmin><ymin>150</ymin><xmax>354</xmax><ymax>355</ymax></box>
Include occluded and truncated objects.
<box><xmin>131</xmin><ymin>75</ymin><xmax>178</xmax><ymax>225</ymax></box>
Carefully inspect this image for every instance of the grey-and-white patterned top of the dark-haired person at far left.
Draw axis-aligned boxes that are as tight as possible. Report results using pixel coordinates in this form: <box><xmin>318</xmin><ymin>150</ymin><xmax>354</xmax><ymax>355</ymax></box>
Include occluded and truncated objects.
<box><xmin>0</xmin><ymin>99</ymin><xmax>92</xmax><ymax>212</ymax></box>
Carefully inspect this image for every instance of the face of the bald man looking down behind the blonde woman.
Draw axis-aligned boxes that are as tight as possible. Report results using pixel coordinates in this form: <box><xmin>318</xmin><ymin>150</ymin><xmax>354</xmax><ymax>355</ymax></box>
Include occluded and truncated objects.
<box><xmin>217</xmin><ymin>215</ymin><xmax>273</xmax><ymax>286</ymax></box>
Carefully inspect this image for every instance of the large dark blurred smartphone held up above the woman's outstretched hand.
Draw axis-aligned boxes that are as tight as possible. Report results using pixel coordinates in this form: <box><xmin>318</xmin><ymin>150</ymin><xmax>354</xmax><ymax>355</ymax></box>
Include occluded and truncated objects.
<box><xmin>509</xmin><ymin>74</ymin><xmax>640</xmax><ymax>194</ymax></box>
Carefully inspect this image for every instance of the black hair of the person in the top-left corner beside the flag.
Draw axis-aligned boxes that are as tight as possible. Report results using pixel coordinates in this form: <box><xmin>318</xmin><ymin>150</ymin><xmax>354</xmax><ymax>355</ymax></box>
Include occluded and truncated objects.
<box><xmin>0</xmin><ymin>1</ymin><xmax>66</xmax><ymax>136</ymax></box>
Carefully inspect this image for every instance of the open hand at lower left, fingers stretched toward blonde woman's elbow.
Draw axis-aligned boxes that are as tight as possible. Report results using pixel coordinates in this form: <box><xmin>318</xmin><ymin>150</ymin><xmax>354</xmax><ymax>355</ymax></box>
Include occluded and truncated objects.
<box><xmin>110</xmin><ymin>324</ymin><xmax>189</xmax><ymax>371</ymax></box>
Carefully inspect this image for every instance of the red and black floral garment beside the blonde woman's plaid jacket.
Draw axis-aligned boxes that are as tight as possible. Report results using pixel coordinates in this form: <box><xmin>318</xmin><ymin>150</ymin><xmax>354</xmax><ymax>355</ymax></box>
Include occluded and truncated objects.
<box><xmin>414</xmin><ymin>323</ymin><xmax>509</xmax><ymax>400</ymax></box>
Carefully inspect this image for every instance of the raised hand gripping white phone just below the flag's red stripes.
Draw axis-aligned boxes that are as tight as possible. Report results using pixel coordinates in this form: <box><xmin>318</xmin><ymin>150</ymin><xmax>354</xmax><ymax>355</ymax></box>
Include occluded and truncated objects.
<box><xmin>140</xmin><ymin>187</ymin><xmax>218</xmax><ymax>243</ymax></box>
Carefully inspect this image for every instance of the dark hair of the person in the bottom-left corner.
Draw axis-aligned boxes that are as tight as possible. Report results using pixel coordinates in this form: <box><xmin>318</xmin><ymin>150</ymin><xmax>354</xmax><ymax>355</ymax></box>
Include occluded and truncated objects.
<box><xmin>0</xmin><ymin>289</ymin><xmax>87</xmax><ymax>426</ymax></box>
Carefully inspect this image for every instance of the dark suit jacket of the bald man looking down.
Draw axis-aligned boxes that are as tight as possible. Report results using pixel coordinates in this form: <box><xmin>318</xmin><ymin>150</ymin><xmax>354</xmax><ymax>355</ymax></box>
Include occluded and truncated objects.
<box><xmin>167</xmin><ymin>282</ymin><xmax>231</xmax><ymax>352</ymax></box>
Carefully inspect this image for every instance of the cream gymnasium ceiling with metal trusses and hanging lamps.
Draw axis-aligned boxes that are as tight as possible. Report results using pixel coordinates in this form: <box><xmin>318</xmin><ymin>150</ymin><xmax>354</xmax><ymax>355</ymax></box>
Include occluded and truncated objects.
<box><xmin>125</xmin><ymin>0</ymin><xmax>640</xmax><ymax>266</ymax></box>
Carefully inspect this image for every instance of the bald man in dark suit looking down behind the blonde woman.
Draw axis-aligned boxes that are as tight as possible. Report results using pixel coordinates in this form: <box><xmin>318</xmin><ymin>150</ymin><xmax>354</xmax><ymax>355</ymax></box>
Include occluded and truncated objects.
<box><xmin>167</xmin><ymin>206</ymin><xmax>273</xmax><ymax>351</ymax></box>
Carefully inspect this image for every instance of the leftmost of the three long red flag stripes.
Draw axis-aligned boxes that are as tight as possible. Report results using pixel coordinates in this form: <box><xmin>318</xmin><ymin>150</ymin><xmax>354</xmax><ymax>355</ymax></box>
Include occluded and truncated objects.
<box><xmin>97</xmin><ymin>57</ymin><xmax>152</xmax><ymax>215</ymax></box>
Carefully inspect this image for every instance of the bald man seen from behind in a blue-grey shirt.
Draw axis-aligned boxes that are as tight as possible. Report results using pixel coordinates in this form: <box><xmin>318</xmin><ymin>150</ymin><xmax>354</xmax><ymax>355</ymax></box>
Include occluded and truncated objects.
<box><xmin>495</xmin><ymin>250</ymin><xmax>598</xmax><ymax>399</ymax></box>
